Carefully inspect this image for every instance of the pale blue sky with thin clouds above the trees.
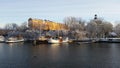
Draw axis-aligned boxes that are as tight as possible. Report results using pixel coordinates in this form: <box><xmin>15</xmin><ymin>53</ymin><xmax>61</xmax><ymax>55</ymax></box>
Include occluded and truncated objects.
<box><xmin>0</xmin><ymin>0</ymin><xmax>120</xmax><ymax>27</ymax></box>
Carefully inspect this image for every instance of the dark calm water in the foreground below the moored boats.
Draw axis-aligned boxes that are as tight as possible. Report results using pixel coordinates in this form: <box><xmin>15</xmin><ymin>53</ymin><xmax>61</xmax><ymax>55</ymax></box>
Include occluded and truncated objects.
<box><xmin>0</xmin><ymin>43</ymin><xmax>120</xmax><ymax>68</ymax></box>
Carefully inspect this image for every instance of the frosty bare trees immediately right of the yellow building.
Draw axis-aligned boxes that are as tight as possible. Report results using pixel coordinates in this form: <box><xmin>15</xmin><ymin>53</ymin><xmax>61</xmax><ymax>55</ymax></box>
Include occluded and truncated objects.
<box><xmin>64</xmin><ymin>17</ymin><xmax>85</xmax><ymax>39</ymax></box>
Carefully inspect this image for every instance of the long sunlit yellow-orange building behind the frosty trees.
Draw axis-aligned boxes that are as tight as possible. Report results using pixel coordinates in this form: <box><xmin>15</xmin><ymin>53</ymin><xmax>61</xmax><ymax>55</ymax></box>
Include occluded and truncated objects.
<box><xmin>28</xmin><ymin>18</ymin><xmax>68</xmax><ymax>30</ymax></box>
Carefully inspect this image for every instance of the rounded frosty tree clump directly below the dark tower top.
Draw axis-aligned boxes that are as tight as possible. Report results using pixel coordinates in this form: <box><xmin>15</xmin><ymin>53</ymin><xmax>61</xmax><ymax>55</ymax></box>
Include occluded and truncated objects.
<box><xmin>86</xmin><ymin>19</ymin><xmax>113</xmax><ymax>38</ymax></box>
